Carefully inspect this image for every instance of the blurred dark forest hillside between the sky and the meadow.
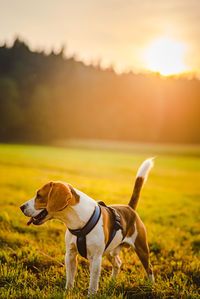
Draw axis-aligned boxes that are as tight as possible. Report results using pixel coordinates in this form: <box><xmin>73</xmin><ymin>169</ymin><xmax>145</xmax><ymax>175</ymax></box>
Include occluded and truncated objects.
<box><xmin>0</xmin><ymin>38</ymin><xmax>200</xmax><ymax>144</ymax></box>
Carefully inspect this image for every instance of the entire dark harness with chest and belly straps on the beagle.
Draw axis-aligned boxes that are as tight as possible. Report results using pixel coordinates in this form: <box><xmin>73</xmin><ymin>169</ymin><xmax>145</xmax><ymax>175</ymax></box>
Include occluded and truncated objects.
<box><xmin>69</xmin><ymin>201</ymin><xmax>123</xmax><ymax>259</ymax></box>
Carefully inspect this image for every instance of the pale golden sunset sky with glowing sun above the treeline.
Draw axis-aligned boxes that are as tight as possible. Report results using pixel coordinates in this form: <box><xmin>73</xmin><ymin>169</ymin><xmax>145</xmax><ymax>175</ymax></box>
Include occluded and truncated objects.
<box><xmin>0</xmin><ymin>0</ymin><xmax>200</xmax><ymax>75</ymax></box>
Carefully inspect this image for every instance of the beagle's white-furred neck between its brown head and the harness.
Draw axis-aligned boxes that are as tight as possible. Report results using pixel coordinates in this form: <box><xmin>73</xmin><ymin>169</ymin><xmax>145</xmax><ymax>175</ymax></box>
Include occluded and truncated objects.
<box><xmin>55</xmin><ymin>188</ymin><xmax>97</xmax><ymax>229</ymax></box>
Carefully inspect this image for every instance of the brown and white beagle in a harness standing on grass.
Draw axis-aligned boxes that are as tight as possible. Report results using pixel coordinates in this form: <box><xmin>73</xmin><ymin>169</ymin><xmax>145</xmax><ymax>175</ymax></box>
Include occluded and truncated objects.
<box><xmin>20</xmin><ymin>158</ymin><xmax>154</xmax><ymax>295</ymax></box>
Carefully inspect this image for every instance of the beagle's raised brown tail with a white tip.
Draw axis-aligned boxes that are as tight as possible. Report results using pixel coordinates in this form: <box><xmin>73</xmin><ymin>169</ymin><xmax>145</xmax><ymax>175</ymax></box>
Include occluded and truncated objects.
<box><xmin>128</xmin><ymin>158</ymin><xmax>154</xmax><ymax>210</ymax></box>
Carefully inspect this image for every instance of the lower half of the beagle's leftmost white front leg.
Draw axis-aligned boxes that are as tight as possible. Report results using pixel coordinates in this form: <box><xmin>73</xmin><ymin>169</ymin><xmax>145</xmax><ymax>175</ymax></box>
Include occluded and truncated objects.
<box><xmin>65</xmin><ymin>249</ymin><xmax>77</xmax><ymax>290</ymax></box>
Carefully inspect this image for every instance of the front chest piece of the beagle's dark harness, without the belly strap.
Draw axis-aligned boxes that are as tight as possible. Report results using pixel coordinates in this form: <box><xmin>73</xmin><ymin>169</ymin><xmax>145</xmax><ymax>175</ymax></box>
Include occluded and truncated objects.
<box><xmin>69</xmin><ymin>205</ymin><xmax>101</xmax><ymax>259</ymax></box>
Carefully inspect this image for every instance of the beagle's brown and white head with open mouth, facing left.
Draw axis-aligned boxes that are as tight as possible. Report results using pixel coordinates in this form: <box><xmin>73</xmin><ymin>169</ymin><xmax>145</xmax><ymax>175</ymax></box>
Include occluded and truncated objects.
<box><xmin>20</xmin><ymin>182</ymin><xmax>79</xmax><ymax>225</ymax></box>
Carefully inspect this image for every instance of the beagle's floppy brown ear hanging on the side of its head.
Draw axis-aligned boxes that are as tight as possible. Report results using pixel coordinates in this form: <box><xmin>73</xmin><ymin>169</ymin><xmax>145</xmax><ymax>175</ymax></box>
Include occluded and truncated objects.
<box><xmin>46</xmin><ymin>182</ymin><xmax>72</xmax><ymax>212</ymax></box>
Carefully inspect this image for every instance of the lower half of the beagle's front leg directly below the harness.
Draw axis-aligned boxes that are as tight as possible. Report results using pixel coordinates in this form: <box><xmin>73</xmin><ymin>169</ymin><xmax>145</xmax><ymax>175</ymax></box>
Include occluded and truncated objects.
<box><xmin>88</xmin><ymin>255</ymin><xmax>102</xmax><ymax>295</ymax></box>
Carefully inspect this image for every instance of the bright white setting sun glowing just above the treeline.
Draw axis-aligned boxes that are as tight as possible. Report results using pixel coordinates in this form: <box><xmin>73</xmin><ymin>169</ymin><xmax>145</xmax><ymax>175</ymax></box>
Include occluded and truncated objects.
<box><xmin>145</xmin><ymin>38</ymin><xmax>187</xmax><ymax>76</ymax></box>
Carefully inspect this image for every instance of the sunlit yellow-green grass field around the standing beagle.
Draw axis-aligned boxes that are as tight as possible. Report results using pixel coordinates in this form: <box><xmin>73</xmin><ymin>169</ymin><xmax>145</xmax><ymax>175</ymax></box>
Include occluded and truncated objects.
<box><xmin>0</xmin><ymin>144</ymin><xmax>200</xmax><ymax>298</ymax></box>
